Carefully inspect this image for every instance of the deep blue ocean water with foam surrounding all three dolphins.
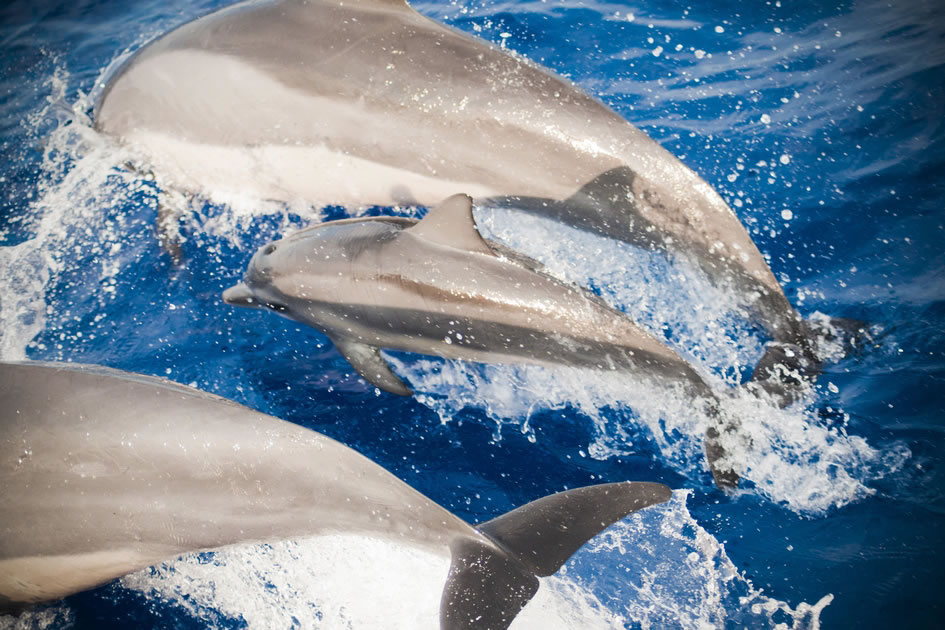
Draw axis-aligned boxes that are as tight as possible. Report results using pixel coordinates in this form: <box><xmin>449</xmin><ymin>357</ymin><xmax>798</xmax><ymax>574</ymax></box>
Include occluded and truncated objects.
<box><xmin>0</xmin><ymin>0</ymin><xmax>945</xmax><ymax>629</ymax></box>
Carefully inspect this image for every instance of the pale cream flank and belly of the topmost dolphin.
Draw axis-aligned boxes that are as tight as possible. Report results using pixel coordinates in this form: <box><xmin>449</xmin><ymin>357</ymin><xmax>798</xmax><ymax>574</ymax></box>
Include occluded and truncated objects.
<box><xmin>97</xmin><ymin>50</ymin><xmax>496</xmax><ymax>207</ymax></box>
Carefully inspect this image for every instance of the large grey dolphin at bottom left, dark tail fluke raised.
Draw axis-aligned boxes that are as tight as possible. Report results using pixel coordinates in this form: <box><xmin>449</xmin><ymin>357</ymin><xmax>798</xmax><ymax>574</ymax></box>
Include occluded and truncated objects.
<box><xmin>0</xmin><ymin>363</ymin><xmax>670</xmax><ymax>630</ymax></box>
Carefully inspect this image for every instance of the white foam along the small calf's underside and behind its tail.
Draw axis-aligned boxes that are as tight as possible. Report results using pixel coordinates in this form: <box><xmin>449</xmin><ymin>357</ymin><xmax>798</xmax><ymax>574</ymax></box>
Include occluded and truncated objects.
<box><xmin>390</xmin><ymin>357</ymin><xmax>908</xmax><ymax>515</ymax></box>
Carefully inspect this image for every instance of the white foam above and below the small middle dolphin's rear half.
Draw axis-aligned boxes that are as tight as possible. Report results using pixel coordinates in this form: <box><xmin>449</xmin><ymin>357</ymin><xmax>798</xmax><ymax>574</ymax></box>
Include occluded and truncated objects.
<box><xmin>392</xmin><ymin>210</ymin><xmax>909</xmax><ymax>514</ymax></box>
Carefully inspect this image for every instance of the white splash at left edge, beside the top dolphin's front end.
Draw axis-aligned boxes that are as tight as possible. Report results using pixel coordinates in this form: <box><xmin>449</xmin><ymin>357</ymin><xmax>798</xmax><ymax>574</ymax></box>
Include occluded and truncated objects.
<box><xmin>0</xmin><ymin>69</ymin><xmax>143</xmax><ymax>360</ymax></box>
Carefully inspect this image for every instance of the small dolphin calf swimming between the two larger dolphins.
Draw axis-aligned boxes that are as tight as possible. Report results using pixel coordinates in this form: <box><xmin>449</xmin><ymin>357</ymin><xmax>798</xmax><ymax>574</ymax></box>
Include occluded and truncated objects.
<box><xmin>223</xmin><ymin>194</ymin><xmax>735</xmax><ymax>485</ymax></box>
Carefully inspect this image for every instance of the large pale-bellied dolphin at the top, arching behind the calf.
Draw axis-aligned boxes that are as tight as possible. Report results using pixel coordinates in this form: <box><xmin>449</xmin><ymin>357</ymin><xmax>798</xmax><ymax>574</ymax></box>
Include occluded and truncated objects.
<box><xmin>95</xmin><ymin>0</ymin><xmax>805</xmax><ymax>350</ymax></box>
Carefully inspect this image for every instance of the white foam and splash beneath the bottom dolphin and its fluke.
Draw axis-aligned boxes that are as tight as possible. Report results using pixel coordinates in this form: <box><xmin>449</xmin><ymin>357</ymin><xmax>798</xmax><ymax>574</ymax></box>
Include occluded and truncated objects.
<box><xmin>29</xmin><ymin>491</ymin><xmax>832</xmax><ymax>630</ymax></box>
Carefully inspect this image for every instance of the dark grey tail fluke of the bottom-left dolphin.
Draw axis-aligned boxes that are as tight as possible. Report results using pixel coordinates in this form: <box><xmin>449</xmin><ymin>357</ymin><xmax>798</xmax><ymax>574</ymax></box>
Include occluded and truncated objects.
<box><xmin>440</xmin><ymin>482</ymin><xmax>672</xmax><ymax>630</ymax></box>
